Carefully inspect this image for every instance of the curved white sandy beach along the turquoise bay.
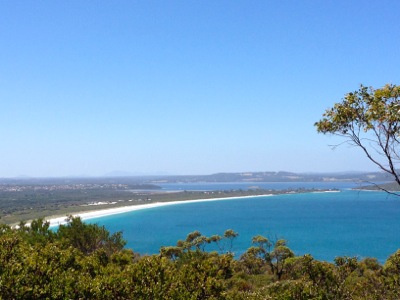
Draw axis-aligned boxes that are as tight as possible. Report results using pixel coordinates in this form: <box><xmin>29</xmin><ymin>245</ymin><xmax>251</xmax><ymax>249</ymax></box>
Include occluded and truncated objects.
<box><xmin>47</xmin><ymin>194</ymin><xmax>272</xmax><ymax>227</ymax></box>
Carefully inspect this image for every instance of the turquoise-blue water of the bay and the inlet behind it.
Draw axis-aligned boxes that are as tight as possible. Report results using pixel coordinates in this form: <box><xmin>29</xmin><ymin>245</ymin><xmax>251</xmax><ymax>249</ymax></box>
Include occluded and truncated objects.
<box><xmin>88</xmin><ymin>182</ymin><xmax>400</xmax><ymax>262</ymax></box>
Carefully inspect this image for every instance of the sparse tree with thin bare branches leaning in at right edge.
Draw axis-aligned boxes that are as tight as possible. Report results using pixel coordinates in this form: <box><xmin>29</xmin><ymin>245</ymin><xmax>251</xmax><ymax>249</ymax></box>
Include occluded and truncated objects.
<box><xmin>314</xmin><ymin>84</ymin><xmax>400</xmax><ymax>190</ymax></box>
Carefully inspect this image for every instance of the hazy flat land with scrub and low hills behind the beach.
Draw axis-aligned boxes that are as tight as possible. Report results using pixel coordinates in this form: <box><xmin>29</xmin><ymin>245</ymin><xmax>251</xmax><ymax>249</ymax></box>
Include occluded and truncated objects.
<box><xmin>0</xmin><ymin>172</ymin><xmax>388</xmax><ymax>224</ymax></box>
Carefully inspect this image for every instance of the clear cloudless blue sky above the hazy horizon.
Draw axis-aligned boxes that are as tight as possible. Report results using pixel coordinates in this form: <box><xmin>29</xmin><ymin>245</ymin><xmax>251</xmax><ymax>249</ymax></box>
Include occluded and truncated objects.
<box><xmin>0</xmin><ymin>0</ymin><xmax>400</xmax><ymax>177</ymax></box>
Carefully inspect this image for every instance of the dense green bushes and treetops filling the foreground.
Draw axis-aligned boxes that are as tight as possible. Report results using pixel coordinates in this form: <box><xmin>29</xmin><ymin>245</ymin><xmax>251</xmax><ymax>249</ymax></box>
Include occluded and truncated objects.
<box><xmin>0</xmin><ymin>217</ymin><xmax>400</xmax><ymax>299</ymax></box>
